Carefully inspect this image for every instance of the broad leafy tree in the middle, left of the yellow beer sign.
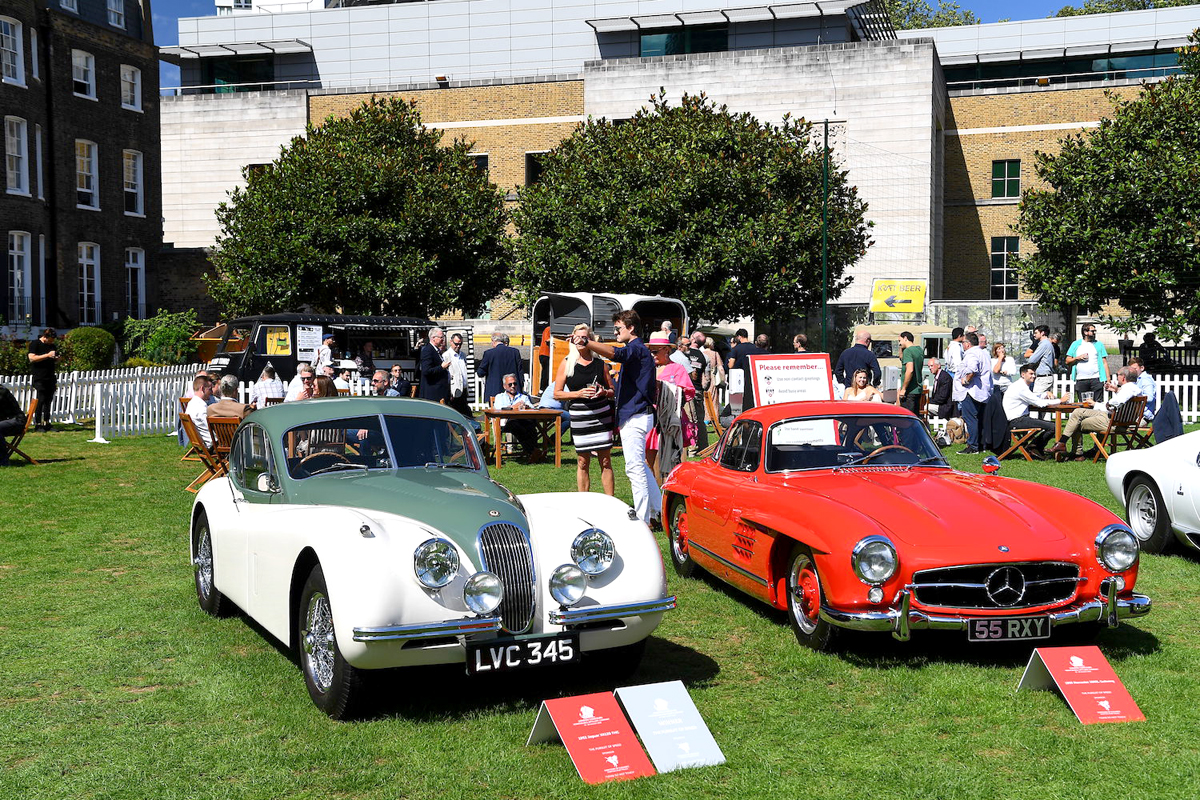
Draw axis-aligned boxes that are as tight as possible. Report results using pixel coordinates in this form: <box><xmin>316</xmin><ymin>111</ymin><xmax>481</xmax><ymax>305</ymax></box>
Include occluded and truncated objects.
<box><xmin>514</xmin><ymin>94</ymin><xmax>870</xmax><ymax>319</ymax></box>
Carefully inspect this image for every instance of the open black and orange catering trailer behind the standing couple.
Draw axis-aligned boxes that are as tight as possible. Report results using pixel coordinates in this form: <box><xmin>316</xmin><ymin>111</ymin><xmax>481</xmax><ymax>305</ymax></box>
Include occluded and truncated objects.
<box><xmin>529</xmin><ymin>291</ymin><xmax>689</xmax><ymax>392</ymax></box>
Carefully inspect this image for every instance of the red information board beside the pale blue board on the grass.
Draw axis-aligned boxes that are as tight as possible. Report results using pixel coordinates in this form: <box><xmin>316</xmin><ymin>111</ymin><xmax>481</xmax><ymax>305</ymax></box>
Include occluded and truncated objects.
<box><xmin>526</xmin><ymin>692</ymin><xmax>655</xmax><ymax>783</ymax></box>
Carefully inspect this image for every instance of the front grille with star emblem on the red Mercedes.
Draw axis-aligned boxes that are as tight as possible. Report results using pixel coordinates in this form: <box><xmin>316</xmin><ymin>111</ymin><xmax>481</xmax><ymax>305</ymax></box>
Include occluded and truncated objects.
<box><xmin>912</xmin><ymin>561</ymin><xmax>1085</xmax><ymax>610</ymax></box>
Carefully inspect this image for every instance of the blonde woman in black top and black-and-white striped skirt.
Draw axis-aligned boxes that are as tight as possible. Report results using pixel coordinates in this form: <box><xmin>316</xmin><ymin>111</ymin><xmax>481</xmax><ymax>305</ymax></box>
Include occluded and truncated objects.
<box><xmin>554</xmin><ymin>325</ymin><xmax>617</xmax><ymax>495</ymax></box>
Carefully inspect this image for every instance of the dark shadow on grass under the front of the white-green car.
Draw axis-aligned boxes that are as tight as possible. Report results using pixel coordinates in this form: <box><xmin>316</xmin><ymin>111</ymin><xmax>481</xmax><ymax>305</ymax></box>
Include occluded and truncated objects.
<box><xmin>368</xmin><ymin>636</ymin><xmax>720</xmax><ymax>724</ymax></box>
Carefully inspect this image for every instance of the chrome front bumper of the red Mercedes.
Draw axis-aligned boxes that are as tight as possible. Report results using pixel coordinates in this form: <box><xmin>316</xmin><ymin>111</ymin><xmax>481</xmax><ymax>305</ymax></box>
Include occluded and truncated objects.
<box><xmin>821</xmin><ymin>581</ymin><xmax>1151</xmax><ymax>642</ymax></box>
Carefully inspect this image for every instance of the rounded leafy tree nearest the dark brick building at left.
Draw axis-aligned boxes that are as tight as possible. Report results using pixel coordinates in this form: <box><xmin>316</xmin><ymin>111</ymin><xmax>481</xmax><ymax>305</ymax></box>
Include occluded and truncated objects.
<box><xmin>205</xmin><ymin>98</ymin><xmax>510</xmax><ymax>317</ymax></box>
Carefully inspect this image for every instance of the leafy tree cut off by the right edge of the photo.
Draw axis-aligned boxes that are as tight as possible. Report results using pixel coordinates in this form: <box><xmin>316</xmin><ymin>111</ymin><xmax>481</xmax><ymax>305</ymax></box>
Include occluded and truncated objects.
<box><xmin>1016</xmin><ymin>31</ymin><xmax>1200</xmax><ymax>339</ymax></box>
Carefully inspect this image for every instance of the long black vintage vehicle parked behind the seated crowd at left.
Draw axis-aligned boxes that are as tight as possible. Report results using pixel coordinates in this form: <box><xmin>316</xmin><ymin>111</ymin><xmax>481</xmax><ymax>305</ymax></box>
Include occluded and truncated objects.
<box><xmin>210</xmin><ymin>314</ymin><xmax>433</xmax><ymax>383</ymax></box>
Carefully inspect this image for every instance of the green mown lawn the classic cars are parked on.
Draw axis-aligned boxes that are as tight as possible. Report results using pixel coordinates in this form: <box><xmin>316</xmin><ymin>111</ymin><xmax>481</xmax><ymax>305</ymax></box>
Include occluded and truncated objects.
<box><xmin>0</xmin><ymin>431</ymin><xmax>1200</xmax><ymax>800</ymax></box>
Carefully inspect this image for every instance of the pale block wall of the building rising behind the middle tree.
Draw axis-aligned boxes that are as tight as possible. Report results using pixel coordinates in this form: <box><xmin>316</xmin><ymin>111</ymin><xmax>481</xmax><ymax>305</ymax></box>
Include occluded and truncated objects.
<box><xmin>584</xmin><ymin>40</ymin><xmax>946</xmax><ymax>302</ymax></box>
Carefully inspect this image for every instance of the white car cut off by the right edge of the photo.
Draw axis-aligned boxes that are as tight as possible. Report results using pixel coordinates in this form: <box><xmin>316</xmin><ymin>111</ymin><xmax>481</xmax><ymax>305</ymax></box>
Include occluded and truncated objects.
<box><xmin>1104</xmin><ymin>431</ymin><xmax>1200</xmax><ymax>553</ymax></box>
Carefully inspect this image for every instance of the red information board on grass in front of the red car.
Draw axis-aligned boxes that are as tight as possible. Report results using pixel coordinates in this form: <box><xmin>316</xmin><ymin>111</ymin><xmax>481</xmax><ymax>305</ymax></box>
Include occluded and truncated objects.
<box><xmin>1016</xmin><ymin>645</ymin><xmax>1146</xmax><ymax>724</ymax></box>
